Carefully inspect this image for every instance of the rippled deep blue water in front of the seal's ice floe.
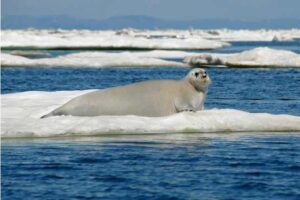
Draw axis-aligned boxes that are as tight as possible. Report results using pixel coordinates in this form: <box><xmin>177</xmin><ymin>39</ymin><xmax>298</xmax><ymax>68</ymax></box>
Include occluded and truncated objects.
<box><xmin>1</xmin><ymin>134</ymin><xmax>300</xmax><ymax>200</ymax></box>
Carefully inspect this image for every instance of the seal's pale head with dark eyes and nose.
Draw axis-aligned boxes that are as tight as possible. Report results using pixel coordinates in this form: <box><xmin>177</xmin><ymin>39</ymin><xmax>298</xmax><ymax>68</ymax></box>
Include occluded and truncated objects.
<box><xmin>185</xmin><ymin>68</ymin><xmax>211</xmax><ymax>92</ymax></box>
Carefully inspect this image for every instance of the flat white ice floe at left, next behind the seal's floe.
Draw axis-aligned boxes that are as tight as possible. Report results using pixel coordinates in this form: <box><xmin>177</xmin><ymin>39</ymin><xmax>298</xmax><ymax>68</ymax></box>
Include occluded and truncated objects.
<box><xmin>1</xmin><ymin>50</ymin><xmax>202</xmax><ymax>67</ymax></box>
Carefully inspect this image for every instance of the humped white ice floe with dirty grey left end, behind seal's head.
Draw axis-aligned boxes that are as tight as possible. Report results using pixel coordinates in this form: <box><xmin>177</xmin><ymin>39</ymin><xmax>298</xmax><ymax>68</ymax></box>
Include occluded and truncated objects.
<box><xmin>183</xmin><ymin>47</ymin><xmax>300</xmax><ymax>67</ymax></box>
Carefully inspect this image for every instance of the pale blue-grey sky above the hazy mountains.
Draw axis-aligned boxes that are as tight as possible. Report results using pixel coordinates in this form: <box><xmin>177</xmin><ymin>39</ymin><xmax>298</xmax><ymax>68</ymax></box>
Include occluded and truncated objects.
<box><xmin>1</xmin><ymin>0</ymin><xmax>300</xmax><ymax>21</ymax></box>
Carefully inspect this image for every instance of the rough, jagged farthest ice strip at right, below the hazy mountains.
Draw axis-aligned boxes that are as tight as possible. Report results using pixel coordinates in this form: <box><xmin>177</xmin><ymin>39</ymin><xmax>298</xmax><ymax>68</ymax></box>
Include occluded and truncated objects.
<box><xmin>94</xmin><ymin>29</ymin><xmax>300</xmax><ymax>42</ymax></box>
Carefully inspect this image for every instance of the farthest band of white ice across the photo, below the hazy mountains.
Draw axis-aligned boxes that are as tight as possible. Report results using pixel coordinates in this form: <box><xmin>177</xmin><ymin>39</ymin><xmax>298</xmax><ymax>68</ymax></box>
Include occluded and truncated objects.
<box><xmin>1</xmin><ymin>29</ymin><xmax>300</xmax><ymax>50</ymax></box>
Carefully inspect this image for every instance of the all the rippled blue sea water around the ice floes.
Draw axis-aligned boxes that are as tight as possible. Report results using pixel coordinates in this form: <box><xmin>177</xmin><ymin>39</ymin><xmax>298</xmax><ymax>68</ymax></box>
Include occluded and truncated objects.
<box><xmin>1</xmin><ymin>42</ymin><xmax>300</xmax><ymax>199</ymax></box>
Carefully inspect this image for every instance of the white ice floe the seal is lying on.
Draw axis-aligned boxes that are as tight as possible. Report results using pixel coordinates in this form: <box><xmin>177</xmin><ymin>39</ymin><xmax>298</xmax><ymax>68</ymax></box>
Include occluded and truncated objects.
<box><xmin>1</xmin><ymin>90</ymin><xmax>300</xmax><ymax>138</ymax></box>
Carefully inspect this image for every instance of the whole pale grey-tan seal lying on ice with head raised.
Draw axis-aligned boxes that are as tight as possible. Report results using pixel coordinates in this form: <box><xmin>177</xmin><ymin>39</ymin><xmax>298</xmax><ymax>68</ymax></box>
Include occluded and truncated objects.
<box><xmin>41</xmin><ymin>68</ymin><xmax>211</xmax><ymax>118</ymax></box>
